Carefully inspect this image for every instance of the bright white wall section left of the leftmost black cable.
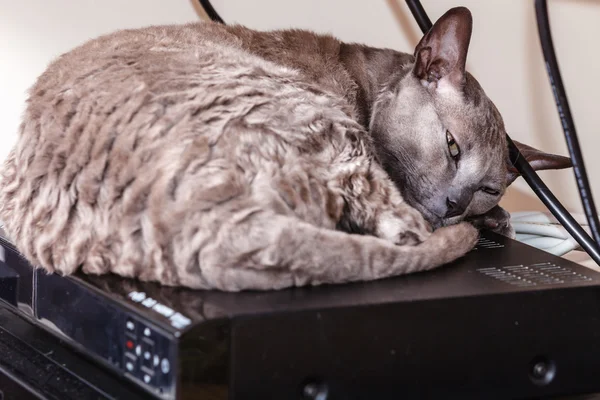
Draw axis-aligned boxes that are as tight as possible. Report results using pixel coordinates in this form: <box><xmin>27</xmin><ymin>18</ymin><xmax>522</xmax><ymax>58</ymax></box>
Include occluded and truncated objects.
<box><xmin>0</xmin><ymin>0</ymin><xmax>204</xmax><ymax>160</ymax></box>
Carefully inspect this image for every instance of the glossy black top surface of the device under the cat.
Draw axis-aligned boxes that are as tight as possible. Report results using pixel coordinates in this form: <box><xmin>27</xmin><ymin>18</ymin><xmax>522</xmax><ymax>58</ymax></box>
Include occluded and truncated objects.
<box><xmin>77</xmin><ymin>233</ymin><xmax>600</xmax><ymax>320</ymax></box>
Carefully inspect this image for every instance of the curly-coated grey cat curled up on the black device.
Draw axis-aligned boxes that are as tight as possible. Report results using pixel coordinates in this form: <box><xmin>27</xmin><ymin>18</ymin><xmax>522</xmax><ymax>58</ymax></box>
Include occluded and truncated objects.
<box><xmin>0</xmin><ymin>7</ymin><xmax>570</xmax><ymax>291</ymax></box>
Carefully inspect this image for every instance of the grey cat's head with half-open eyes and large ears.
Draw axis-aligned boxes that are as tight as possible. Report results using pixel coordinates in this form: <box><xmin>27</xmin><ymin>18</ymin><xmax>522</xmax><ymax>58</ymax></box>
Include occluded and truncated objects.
<box><xmin>370</xmin><ymin>7</ymin><xmax>571</xmax><ymax>227</ymax></box>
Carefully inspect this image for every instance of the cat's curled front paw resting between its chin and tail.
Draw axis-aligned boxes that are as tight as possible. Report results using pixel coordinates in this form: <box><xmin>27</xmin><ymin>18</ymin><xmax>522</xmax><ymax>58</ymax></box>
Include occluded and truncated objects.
<box><xmin>376</xmin><ymin>207</ymin><xmax>433</xmax><ymax>246</ymax></box>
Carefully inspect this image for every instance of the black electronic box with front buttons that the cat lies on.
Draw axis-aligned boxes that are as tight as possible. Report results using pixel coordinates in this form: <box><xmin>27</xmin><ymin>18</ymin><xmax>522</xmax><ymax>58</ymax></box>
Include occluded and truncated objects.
<box><xmin>0</xmin><ymin>228</ymin><xmax>600</xmax><ymax>400</ymax></box>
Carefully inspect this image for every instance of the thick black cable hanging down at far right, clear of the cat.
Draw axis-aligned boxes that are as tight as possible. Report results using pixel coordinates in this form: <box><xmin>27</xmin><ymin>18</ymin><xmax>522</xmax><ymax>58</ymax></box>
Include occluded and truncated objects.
<box><xmin>535</xmin><ymin>0</ymin><xmax>600</xmax><ymax>247</ymax></box>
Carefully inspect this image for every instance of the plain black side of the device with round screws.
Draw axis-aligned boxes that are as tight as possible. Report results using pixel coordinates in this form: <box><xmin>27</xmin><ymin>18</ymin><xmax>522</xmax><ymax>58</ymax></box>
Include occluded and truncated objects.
<box><xmin>231</xmin><ymin>287</ymin><xmax>600</xmax><ymax>399</ymax></box>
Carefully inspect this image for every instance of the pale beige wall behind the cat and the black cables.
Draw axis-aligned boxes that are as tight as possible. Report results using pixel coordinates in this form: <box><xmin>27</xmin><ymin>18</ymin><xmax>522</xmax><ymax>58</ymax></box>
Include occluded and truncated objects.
<box><xmin>0</xmin><ymin>0</ymin><xmax>600</xmax><ymax>216</ymax></box>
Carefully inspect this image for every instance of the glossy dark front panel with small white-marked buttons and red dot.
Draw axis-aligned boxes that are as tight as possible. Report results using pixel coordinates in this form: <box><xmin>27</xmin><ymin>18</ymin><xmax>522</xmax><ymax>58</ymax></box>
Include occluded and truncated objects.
<box><xmin>36</xmin><ymin>271</ymin><xmax>177</xmax><ymax>398</ymax></box>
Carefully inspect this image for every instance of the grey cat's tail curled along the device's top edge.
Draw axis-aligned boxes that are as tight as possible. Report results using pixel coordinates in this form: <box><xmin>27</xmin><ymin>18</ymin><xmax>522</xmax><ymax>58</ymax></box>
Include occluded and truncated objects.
<box><xmin>192</xmin><ymin>216</ymin><xmax>478</xmax><ymax>291</ymax></box>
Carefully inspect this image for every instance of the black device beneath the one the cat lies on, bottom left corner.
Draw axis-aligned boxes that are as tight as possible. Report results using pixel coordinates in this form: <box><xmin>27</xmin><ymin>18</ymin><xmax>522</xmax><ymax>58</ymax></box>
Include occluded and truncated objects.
<box><xmin>0</xmin><ymin>306</ymin><xmax>147</xmax><ymax>400</ymax></box>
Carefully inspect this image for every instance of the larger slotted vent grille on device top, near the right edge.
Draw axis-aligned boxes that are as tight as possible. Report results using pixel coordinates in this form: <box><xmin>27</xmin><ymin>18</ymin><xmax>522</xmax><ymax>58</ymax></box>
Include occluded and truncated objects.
<box><xmin>477</xmin><ymin>262</ymin><xmax>592</xmax><ymax>287</ymax></box>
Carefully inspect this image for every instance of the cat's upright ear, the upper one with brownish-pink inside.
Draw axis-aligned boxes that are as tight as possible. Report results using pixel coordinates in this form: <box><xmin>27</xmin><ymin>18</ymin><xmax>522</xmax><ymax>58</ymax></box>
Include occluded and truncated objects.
<box><xmin>413</xmin><ymin>7</ymin><xmax>473</xmax><ymax>88</ymax></box>
